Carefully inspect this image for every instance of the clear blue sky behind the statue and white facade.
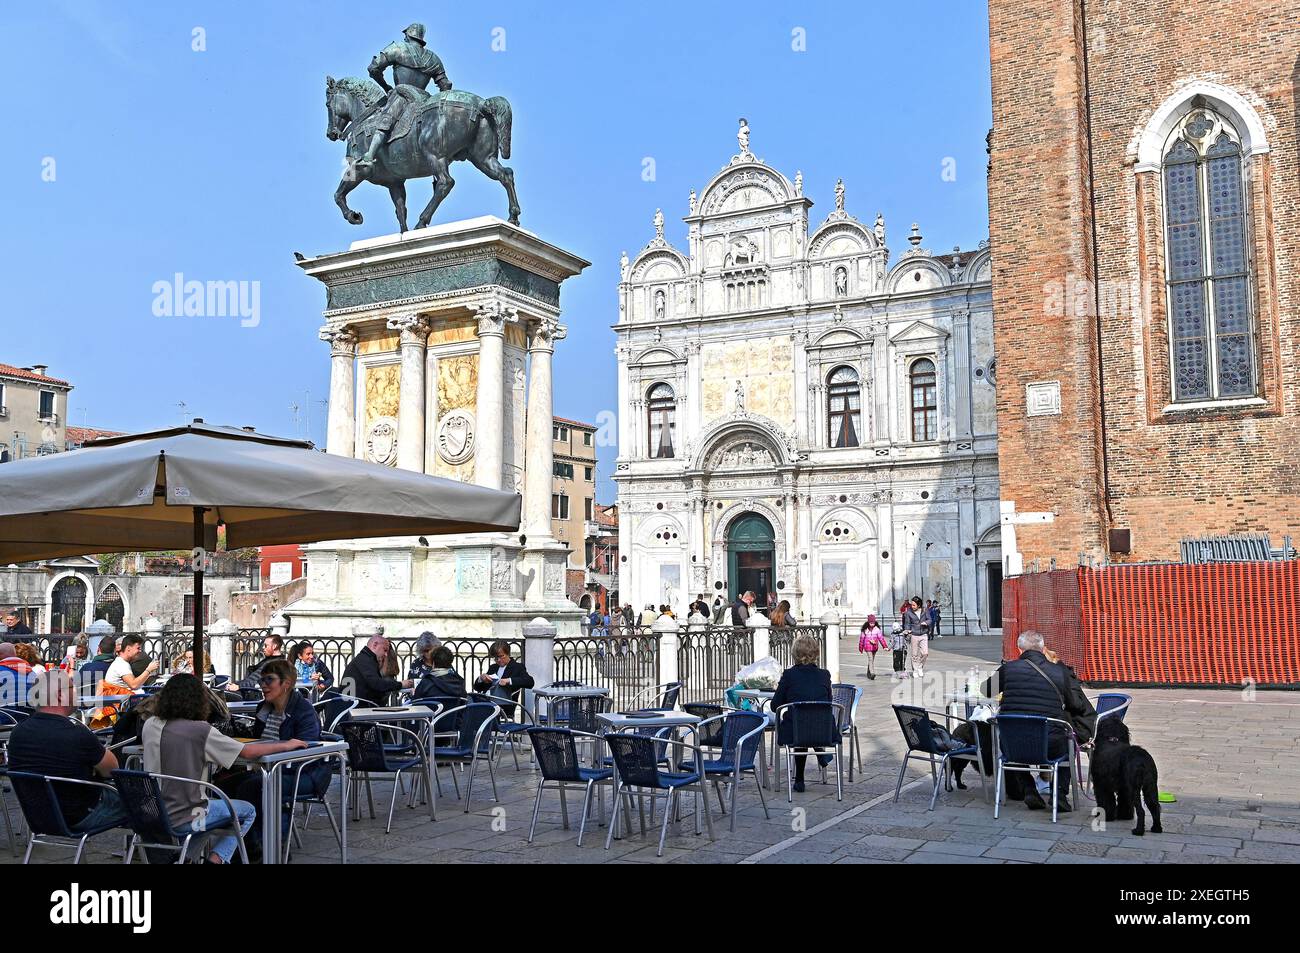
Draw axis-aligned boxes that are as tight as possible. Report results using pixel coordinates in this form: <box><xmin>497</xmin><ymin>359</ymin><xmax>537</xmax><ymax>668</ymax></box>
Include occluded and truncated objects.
<box><xmin>0</xmin><ymin>0</ymin><xmax>991</xmax><ymax>502</ymax></box>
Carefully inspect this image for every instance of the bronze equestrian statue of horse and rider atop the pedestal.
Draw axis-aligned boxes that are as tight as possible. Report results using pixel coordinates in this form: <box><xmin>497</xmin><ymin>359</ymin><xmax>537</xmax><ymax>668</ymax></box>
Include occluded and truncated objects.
<box><xmin>325</xmin><ymin>23</ymin><xmax>519</xmax><ymax>231</ymax></box>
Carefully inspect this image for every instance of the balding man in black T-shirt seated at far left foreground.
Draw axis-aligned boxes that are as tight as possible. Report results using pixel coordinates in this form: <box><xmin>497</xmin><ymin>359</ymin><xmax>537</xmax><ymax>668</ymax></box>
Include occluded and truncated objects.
<box><xmin>9</xmin><ymin>671</ymin><xmax>126</xmax><ymax>833</ymax></box>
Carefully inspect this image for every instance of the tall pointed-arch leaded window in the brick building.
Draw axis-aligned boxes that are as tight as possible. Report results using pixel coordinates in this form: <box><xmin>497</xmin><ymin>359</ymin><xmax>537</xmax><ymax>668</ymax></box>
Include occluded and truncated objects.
<box><xmin>1161</xmin><ymin>108</ymin><xmax>1256</xmax><ymax>400</ymax></box>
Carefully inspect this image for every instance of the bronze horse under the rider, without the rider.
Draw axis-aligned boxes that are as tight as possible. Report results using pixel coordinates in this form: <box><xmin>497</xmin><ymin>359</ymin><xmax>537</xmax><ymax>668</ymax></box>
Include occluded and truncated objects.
<box><xmin>325</xmin><ymin>77</ymin><xmax>519</xmax><ymax>231</ymax></box>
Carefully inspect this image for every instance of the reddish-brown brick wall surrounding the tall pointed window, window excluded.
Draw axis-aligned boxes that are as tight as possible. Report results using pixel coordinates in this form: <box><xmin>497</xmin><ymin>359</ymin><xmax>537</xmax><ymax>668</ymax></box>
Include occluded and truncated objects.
<box><xmin>989</xmin><ymin>0</ymin><xmax>1300</xmax><ymax>564</ymax></box>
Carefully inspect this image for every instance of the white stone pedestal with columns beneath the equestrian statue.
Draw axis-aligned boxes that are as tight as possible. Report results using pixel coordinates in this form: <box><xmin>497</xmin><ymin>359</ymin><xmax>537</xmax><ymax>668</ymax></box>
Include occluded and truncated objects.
<box><xmin>292</xmin><ymin>217</ymin><xmax>588</xmax><ymax>638</ymax></box>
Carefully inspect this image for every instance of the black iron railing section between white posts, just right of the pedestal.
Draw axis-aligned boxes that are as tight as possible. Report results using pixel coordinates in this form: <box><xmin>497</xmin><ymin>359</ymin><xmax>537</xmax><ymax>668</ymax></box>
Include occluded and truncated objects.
<box><xmin>554</xmin><ymin>625</ymin><xmax>659</xmax><ymax>711</ymax></box>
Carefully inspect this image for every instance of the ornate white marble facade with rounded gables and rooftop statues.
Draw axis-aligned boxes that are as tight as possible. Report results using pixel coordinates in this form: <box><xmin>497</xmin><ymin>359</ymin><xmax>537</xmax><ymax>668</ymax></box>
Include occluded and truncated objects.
<box><xmin>615</xmin><ymin>124</ymin><xmax>1001</xmax><ymax>633</ymax></box>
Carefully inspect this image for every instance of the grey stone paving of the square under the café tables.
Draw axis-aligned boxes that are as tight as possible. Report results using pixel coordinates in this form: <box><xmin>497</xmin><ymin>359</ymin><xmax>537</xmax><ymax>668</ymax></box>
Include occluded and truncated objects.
<box><xmin>0</xmin><ymin>637</ymin><xmax>1300</xmax><ymax>863</ymax></box>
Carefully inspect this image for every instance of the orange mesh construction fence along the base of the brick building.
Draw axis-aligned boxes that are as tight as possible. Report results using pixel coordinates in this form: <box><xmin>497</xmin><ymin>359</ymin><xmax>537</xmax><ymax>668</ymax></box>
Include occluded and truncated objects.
<box><xmin>1002</xmin><ymin>560</ymin><xmax>1300</xmax><ymax>686</ymax></box>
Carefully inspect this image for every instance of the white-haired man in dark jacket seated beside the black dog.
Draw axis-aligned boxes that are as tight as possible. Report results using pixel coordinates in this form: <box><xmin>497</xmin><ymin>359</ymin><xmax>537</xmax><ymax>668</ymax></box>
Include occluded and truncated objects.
<box><xmin>984</xmin><ymin>632</ymin><xmax>1097</xmax><ymax>811</ymax></box>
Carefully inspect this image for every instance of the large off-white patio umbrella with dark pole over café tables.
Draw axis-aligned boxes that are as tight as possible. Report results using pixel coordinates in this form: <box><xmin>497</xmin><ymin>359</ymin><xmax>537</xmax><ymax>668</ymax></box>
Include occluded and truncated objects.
<box><xmin>0</xmin><ymin>420</ymin><xmax>520</xmax><ymax>671</ymax></box>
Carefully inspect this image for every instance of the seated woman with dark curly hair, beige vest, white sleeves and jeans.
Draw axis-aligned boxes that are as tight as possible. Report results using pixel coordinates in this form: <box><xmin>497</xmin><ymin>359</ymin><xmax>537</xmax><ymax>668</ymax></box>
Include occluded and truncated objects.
<box><xmin>140</xmin><ymin>675</ymin><xmax>307</xmax><ymax>863</ymax></box>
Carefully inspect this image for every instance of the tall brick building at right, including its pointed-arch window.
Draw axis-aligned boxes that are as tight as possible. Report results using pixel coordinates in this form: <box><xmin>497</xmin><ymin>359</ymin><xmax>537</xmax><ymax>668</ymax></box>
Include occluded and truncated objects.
<box><xmin>989</xmin><ymin>0</ymin><xmax>1300</xmax><ymax>573</ymax></box>
